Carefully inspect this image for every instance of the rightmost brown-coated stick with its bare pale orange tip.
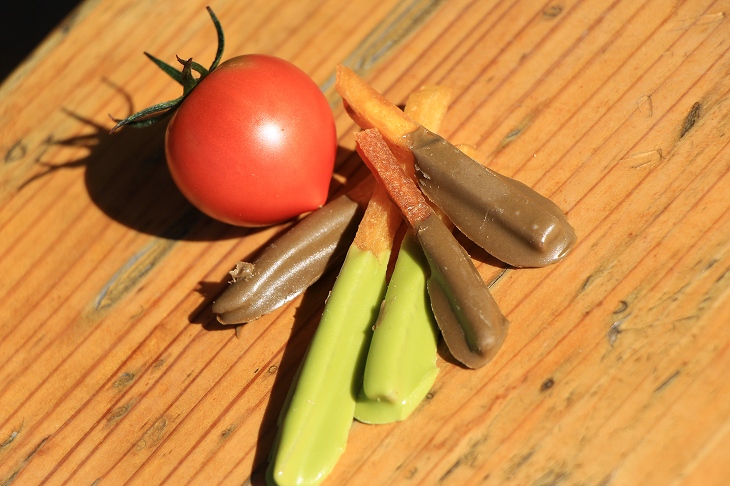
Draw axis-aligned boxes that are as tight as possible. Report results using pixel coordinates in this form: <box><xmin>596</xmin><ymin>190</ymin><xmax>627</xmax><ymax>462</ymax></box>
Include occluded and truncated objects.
<box><xmin>337</xmin><ymin>66</ymin><xmax>576</xmax><ymax>267</ymax></box>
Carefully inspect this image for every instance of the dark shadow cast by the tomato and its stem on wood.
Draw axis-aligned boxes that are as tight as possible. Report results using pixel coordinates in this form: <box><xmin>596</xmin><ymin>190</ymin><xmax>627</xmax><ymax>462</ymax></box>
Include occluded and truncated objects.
<box><xmin>20</xmin><ymin>99</ymin><xmax>250</xmax><ymax>241</ymax></box>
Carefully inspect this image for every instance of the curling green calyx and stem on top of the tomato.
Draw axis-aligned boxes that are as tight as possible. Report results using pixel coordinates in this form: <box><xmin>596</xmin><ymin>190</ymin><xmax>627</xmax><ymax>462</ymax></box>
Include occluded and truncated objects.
<box><xmin>109</xmin><ymin>7</ymin><xmax>225</xmax><ymax>132</ymax></box>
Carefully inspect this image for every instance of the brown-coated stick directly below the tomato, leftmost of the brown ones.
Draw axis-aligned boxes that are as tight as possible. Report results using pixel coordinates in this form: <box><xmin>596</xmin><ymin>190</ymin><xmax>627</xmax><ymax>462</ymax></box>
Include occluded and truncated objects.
<box><xmin>213</xmin><ymin>178</ymin><xmax>373</xmax><ymax>324</ymax></box>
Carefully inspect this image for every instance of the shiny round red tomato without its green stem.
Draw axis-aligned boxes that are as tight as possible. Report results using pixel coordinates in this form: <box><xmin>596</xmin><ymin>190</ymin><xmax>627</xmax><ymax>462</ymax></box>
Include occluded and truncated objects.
<box><xmin>165</xmin><ymin>54</ymin><xmax>337</xmax><ymax>226</ymax></box>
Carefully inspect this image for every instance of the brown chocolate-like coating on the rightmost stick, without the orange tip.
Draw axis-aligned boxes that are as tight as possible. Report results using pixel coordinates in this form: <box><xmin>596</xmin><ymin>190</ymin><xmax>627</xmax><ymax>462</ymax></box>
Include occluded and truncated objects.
<box><xmin>407</xmin><ymin>127</ymin><xmax>576</xmax><ymax>267</ymax></box>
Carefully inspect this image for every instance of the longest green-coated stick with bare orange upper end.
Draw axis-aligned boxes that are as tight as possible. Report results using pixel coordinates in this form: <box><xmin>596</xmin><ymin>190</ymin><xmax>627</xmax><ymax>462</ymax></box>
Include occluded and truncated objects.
<box><xmin>267</xmin><ymin>185</ymin><xmax>401</xmax><ymax>485</ymax></box>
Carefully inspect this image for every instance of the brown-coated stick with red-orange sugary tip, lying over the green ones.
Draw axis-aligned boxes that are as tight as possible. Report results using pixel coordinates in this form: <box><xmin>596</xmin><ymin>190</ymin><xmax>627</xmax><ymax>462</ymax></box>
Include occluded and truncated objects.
<box><xmin>355</xmin><ymin>129</ymin><xmax>507</xmax><ymax>368</ymax></box>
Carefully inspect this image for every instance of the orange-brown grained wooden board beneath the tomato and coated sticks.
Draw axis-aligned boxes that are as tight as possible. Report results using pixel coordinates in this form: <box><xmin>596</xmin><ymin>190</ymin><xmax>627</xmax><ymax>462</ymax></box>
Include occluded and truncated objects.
<box><xmin>0</xmin><ymin>0</ymin><xmax>730</xmax><ymax>485</ymax></box>
